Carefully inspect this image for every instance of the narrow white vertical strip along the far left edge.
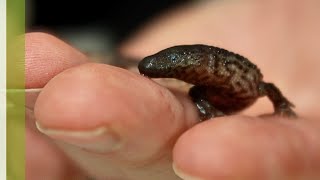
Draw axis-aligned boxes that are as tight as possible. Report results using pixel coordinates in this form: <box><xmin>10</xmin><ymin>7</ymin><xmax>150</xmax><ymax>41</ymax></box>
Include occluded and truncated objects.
<box><xmin>0</xmin><ymin>0</ymin><xmax>7</xmax><ymax>179</ymax></box>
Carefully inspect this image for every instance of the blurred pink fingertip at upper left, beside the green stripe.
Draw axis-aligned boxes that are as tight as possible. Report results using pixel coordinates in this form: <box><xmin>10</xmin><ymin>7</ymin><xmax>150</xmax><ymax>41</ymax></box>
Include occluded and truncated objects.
<box><xmin>25</xmin><ymin>32</ymin><xmax>88</xmax><ymax>88</ymax></box>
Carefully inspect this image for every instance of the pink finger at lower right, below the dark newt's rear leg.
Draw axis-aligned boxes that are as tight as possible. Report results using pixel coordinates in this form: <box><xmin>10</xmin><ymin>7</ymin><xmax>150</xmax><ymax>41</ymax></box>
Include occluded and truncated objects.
<box><xmin>173</xmin><ymin>116</ymin><xmax>320</xmax><ymax>180</ymax></box>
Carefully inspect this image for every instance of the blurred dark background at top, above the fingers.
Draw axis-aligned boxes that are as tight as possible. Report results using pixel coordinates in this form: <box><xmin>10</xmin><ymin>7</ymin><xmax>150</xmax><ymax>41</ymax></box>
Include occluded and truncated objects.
<box><xmin>26</xmin><ymin>0</ymin><xmax>191</xmax><ymax>57</ymax></box>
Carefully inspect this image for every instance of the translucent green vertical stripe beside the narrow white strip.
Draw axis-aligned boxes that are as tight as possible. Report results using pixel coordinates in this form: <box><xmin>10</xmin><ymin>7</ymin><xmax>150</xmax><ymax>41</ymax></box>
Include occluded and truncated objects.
<box><xmin>6</xmin><ymin>0</ymin><xmax>25</xmax><ymax>180</ymax></box>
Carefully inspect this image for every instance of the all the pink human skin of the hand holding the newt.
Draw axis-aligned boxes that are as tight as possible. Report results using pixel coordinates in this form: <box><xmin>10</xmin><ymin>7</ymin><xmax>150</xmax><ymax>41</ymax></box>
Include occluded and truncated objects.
<box><xmin>26</xmin><ymin>0</ymin><xmax>320</xmax><ymax>180</ymax></box>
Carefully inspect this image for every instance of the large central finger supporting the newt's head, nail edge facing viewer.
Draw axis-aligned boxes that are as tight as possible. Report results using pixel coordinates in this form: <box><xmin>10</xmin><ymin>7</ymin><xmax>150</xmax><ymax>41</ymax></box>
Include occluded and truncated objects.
<box><xmin>35</xmin><ymin>63</ymin><xmax>197</xmax><ymax>179</ymax></box>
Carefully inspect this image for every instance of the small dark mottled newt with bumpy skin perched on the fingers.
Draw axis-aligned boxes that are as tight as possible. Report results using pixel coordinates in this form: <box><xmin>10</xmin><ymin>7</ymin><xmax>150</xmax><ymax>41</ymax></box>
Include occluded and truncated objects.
<box><xmin>138</xmin><ymin>44</ymin><xmax>296</xmax><ymax>120</ymax></box>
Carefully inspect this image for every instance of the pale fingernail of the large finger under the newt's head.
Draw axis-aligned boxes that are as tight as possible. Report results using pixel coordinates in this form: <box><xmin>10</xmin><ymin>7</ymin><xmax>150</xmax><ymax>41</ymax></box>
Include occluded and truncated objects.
<box><xmin>36</xmin><ymin>122</ymin><xmax>122</xmax><ymax>153</ymax></box>
